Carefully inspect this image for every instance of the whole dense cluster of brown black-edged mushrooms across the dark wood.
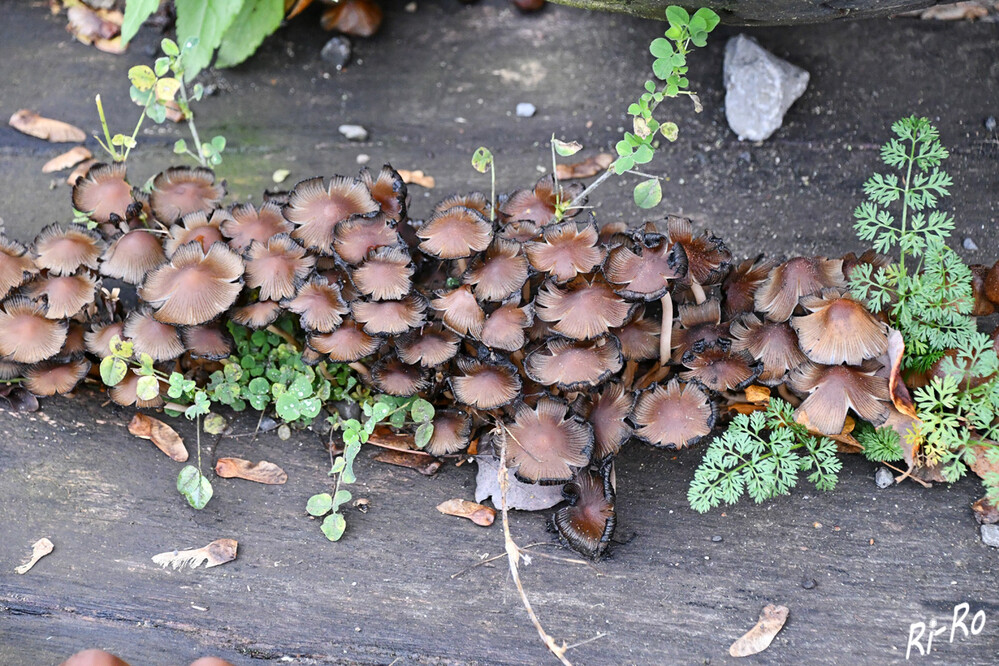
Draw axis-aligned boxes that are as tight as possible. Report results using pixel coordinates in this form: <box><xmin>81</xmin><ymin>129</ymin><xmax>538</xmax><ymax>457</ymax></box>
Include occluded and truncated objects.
<box><xmin>7</xmin><ymin>165</ymin><xmax>999</xmax><ymax>557</ymax></box>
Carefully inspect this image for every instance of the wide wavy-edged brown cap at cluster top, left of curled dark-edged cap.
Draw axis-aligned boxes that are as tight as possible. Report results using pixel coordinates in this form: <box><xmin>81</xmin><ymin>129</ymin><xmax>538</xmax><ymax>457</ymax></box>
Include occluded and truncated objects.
<box><xmin>292</xmin><ymin>176</ymin><xmax>381</xmax><ymax>254</ymax></box>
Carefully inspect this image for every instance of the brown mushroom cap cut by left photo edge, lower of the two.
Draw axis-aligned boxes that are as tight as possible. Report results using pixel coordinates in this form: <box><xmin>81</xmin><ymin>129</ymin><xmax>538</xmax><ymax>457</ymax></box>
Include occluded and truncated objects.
<box><xmin>0</xmin><ymin>296</ymin><xmax>69</xmax><ymax>363</ymax></box>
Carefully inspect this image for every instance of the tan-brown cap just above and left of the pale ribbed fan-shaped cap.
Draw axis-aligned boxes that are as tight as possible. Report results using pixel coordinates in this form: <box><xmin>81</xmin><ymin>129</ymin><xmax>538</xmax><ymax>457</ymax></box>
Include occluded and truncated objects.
<box><xmin>754</xmin><ymin>257</ymin><xmax>846</xmax><ymax>321</ymax></box>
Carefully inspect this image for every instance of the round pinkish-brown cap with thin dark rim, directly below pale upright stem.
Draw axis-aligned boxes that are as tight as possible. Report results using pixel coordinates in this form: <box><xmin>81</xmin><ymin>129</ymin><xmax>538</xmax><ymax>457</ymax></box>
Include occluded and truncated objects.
<box><xmin>632</xmin><ymin>378</ymin><xmax>716</xmax><ymax>449</ymax></box>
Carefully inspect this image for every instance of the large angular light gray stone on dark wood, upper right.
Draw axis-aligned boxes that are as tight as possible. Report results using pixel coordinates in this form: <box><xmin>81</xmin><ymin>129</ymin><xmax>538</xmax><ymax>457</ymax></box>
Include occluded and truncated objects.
<box><xmin>725</xmin><ymin>35</ymin><xmax>808</xmax><ymax>141</ymax></box>
